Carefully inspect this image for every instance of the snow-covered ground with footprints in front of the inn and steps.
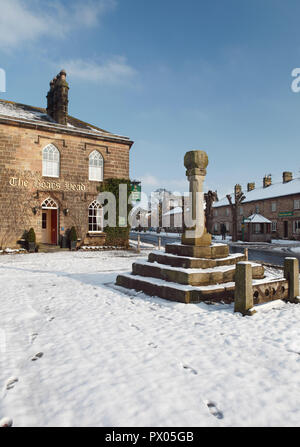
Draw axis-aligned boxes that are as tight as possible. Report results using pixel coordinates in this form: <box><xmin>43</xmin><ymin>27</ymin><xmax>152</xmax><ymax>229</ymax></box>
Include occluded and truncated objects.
<box><xmin>0</xmin><ymin>251</ymin><xmax>300</xmax><ymax>427</ymax></box>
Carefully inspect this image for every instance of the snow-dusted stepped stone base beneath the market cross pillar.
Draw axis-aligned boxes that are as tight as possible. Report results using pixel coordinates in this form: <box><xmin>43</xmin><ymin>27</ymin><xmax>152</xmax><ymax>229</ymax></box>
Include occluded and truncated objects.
<box><xmin>116</xmin><ymin>244</ymin><xmax>267</xmax><ymax>303</ymax></box>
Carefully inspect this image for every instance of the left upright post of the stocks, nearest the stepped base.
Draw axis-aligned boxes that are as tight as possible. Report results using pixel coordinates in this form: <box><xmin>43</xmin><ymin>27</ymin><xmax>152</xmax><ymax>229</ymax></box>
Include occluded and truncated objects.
<box><xmin>234</xmin><ymin>261</ymin><xmax>256</xmax><ymax>315</ymax></box>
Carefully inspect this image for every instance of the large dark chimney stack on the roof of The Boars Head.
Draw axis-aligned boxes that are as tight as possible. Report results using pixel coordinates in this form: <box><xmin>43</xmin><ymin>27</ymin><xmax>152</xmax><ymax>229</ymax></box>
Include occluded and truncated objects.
<box><xmin>47</xmin><ymin>70</ymin><xmax>69</xmax><ymax>125</ymax></box>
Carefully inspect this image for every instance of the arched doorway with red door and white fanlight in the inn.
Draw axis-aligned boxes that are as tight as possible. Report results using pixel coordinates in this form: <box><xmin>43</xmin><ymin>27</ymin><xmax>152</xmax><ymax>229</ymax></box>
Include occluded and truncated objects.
<box><xmin>42</xmin><ymin>197</ymin><xmax>58</xmax><ymax>245</ymax></box>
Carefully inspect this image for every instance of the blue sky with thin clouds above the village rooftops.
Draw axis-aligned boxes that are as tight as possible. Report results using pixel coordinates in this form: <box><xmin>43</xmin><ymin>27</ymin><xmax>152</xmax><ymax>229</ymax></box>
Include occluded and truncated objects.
<box><xmin>0</xmin><ymin>0</ymin><xmax>300</xmax><ymax>198</ymax></box>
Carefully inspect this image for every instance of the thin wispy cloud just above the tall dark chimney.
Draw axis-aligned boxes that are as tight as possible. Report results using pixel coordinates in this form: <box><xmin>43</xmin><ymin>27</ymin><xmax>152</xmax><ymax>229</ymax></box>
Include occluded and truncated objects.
<box><xmin>60</xmin><ymin>56</ymin><xmax>137</xmax><ymax>84</ymax></box>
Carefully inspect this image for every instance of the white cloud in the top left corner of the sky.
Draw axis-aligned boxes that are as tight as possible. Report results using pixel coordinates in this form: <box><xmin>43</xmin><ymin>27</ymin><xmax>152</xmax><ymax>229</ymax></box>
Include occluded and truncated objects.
<box><xmin>0</xmin><ymin>0</ymin><xmax>116</xmax><ymax>50</ymax></box>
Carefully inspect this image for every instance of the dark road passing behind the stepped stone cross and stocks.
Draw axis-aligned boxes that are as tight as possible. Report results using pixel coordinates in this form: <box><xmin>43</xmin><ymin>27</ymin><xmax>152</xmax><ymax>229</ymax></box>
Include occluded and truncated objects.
<box><xmin>130</xmin><ymin>232</ymin><xmax>300</xmax><ymax>266</ymax></box>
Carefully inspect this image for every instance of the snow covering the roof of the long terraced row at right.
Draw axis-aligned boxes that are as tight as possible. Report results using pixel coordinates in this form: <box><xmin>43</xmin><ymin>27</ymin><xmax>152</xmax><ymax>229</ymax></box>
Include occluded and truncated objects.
<box><xmin>213</xmin><ymin>178</ymin><xmax>300</xmax><ymax>208</ymax></box>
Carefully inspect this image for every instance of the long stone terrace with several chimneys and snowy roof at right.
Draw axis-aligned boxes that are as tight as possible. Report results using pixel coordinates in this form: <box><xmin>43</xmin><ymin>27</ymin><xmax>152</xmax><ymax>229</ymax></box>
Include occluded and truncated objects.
<box><xmin>213</xmin><ymin>172</ymin><xmax>300</xmax><ymax>241</ymax></box>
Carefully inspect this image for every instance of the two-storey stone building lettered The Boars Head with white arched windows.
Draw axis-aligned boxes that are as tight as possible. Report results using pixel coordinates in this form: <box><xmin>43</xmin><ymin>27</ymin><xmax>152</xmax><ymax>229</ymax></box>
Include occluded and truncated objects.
<box><xmin>0</xmin><ymin>70</ymin><xmax>133</xmax><ymax>247</ymax></box>
